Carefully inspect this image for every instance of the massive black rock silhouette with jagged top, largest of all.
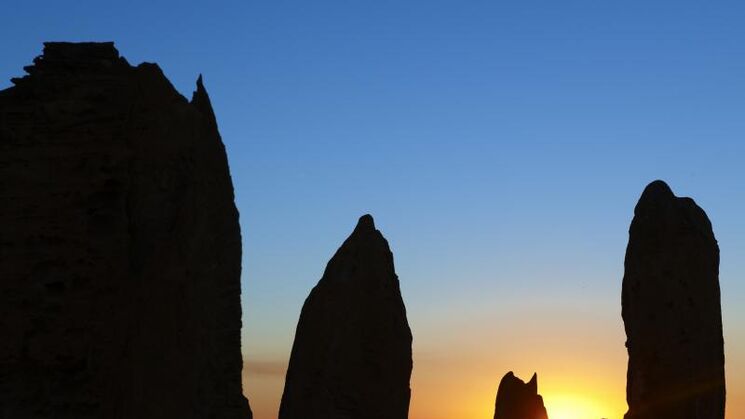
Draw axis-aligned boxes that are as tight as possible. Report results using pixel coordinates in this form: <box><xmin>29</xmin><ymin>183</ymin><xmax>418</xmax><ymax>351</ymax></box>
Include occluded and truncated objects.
<box><xmin>0</xmin><ymin>43</ymin><xmax>251</xmax><ymax>419</ymax></box>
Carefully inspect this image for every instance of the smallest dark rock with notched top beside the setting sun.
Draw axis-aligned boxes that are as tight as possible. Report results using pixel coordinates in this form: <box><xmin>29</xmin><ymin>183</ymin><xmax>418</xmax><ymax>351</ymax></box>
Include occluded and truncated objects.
<box><xmin>494</xmin><ymin>371</ymin><xmax>548</xmax><ymax>419</ymax></box>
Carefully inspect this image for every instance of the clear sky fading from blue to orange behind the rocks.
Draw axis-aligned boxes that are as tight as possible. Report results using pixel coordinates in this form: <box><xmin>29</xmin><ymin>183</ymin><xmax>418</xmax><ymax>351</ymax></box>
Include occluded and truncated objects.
<box><xmin>0</xmin><ymin>0</ymin><xmax>745</xmax><ymax>419</ymax></box>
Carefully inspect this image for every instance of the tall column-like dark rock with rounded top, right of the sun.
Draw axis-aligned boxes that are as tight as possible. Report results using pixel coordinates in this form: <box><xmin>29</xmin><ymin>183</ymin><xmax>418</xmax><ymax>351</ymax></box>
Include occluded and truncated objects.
<box><xmin>622</xmin><ymin>181</ymin><xmax>725</xmax><ymax>419</ymax></box>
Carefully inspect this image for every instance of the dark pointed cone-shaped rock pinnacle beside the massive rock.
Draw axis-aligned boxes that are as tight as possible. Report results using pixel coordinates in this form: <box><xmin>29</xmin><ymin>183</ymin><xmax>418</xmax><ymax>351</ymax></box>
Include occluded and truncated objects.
<box><xmin>279</xmin><ymin>215</ymin><xmax>412</xmax><ymax>419</ymax></box>
